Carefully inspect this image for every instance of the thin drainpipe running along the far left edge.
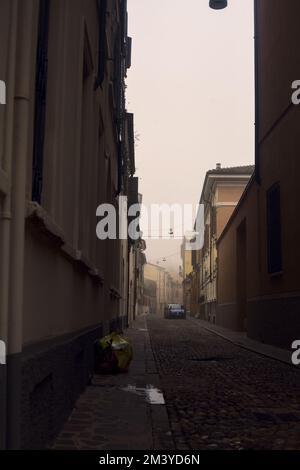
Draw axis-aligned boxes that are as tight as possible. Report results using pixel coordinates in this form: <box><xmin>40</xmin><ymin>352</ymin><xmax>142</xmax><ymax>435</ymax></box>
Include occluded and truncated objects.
<box><xmin>0</xmin><ymin>0</ymin><xmax>18</xmax><ymax>449</ymax></box>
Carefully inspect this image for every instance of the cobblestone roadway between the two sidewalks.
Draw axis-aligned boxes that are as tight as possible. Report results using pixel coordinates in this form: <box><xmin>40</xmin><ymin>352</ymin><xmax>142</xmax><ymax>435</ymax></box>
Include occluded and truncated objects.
<box><xmin>148</xmin><ymin>318</ymin><xmax>300</xmax><ymax>450</ymax></box>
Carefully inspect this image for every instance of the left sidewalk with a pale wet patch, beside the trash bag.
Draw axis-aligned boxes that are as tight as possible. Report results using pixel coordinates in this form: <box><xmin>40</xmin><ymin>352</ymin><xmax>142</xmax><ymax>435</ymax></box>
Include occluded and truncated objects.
<box><xmin>53</xmin><ymin>317</ymin><xmax>174</xmax><ymax>450</ymax></box>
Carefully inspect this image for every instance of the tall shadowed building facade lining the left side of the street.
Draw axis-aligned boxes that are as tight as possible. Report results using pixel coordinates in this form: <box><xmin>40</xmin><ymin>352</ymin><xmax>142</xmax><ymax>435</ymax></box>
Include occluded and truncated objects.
<box><xmin>0</xmin><ymin>0</ymin><xmax>134</xmax><ymax>449</ymax></box>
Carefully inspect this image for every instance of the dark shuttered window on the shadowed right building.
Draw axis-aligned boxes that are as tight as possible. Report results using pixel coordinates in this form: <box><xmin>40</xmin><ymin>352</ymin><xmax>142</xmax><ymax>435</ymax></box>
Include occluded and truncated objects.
<box><xmin>267</xmin><ymin>183</ymin><xmax>282</xmax><ymax>274</ymax></box>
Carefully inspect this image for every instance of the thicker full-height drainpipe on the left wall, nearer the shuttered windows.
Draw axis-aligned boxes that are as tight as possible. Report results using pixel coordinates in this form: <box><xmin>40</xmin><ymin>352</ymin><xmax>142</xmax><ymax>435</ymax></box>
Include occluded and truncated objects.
<box><xmin>7</xmin><ymin>0</ymin><xmax>38</xmax><ymax>449</ymax></box>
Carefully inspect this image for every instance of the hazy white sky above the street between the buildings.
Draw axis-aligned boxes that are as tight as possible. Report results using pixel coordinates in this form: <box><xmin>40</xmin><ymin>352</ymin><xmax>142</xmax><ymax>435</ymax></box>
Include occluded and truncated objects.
<box><xmin>127</xmin><ymin>0</ymin><xmax>254</xmax><ymax>276</ymax></box>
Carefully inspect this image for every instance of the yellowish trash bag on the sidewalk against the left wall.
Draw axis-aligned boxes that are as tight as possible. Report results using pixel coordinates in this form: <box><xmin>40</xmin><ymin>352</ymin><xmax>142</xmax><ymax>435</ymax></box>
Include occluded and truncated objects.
<box><xmin>95</xmin><ymin>332</ymin><xmax>133</xmax><ymax>374</ymax></box>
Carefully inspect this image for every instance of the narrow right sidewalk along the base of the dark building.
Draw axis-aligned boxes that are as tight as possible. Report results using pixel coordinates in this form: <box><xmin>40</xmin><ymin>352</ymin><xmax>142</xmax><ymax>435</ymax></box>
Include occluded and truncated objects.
<box><xmin>189</xmin><ymin>317</ymin><xmax>294</xmax><ymax>367</ymax></box>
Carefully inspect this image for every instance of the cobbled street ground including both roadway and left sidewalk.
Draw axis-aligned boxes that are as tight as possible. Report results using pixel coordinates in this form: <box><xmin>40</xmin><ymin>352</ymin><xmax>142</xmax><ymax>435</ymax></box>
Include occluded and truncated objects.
<box><xmin>54</xmin><ymin>317</ymin><xmax>300</xmax><ymax>450</ymax></box>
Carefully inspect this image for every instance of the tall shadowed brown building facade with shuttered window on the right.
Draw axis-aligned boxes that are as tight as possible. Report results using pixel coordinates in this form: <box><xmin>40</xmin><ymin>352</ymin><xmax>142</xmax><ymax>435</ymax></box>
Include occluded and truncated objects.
<box><xmin>217</xmin><ymin>0</ymin><xmax>300</xmax><ymax>349</ymax></box>
